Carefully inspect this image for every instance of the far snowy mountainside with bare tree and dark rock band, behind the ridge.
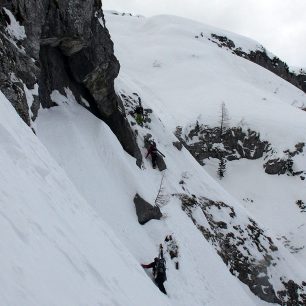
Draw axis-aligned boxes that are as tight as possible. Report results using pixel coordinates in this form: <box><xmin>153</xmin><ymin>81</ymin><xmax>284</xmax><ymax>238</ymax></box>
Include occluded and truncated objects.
<box><xmin>102</xmin><ymin>12</ymin><xmax>306</xmax><ymax>304</ymax></box>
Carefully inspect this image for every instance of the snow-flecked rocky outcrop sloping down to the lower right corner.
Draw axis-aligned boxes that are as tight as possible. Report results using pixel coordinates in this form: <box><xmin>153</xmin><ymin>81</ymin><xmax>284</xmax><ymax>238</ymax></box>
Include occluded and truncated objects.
<box><xmin>176</xmin><ymin>194</ymin><xmax>306</xmax><ymax>306</ymax></box>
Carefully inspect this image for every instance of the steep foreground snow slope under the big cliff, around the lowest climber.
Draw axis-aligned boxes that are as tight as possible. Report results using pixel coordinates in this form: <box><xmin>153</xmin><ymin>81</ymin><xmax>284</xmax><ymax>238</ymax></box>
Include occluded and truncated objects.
<box><xmin>0</xmin><ymin>90</ymin><xmax>264</xmax><ymax>306</ymax></box>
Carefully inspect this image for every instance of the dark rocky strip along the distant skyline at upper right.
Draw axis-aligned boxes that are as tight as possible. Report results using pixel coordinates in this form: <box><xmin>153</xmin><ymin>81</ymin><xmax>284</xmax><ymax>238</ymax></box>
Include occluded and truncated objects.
<box><xmin>210</xmin><ymin>34</ymin><xmax>306</xmax><ymax>92</ymax></box>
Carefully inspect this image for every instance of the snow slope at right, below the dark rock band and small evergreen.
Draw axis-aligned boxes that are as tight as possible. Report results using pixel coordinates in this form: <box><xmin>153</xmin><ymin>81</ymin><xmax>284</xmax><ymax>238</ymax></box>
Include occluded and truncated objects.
<box><xmin>205</xmin><ymin>154</ymin><xmax>306</xmax><ymax>265</ymax></box>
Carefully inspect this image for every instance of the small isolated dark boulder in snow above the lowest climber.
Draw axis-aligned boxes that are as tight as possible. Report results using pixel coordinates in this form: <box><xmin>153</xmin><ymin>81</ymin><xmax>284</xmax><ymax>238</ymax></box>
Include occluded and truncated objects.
<box><xmin>134</xmin><ymin>193</ymin><xmax>162</xmax><ymax>225</ymax></box>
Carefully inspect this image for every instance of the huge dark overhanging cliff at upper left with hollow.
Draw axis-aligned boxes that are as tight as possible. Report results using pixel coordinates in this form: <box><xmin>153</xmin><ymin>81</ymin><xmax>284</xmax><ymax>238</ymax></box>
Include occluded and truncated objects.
<box><xmin>0</xmin><ymin>0</ymin><xmax>141</xmax><ymax>164</ymax></box>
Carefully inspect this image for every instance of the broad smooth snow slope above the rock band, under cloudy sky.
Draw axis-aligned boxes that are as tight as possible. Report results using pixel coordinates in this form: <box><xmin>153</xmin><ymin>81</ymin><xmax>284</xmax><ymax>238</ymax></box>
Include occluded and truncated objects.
<box><xmin>106</xmin><ymin>13</ymin><xmax>306</xmax><ymax>149</ymax></box>
